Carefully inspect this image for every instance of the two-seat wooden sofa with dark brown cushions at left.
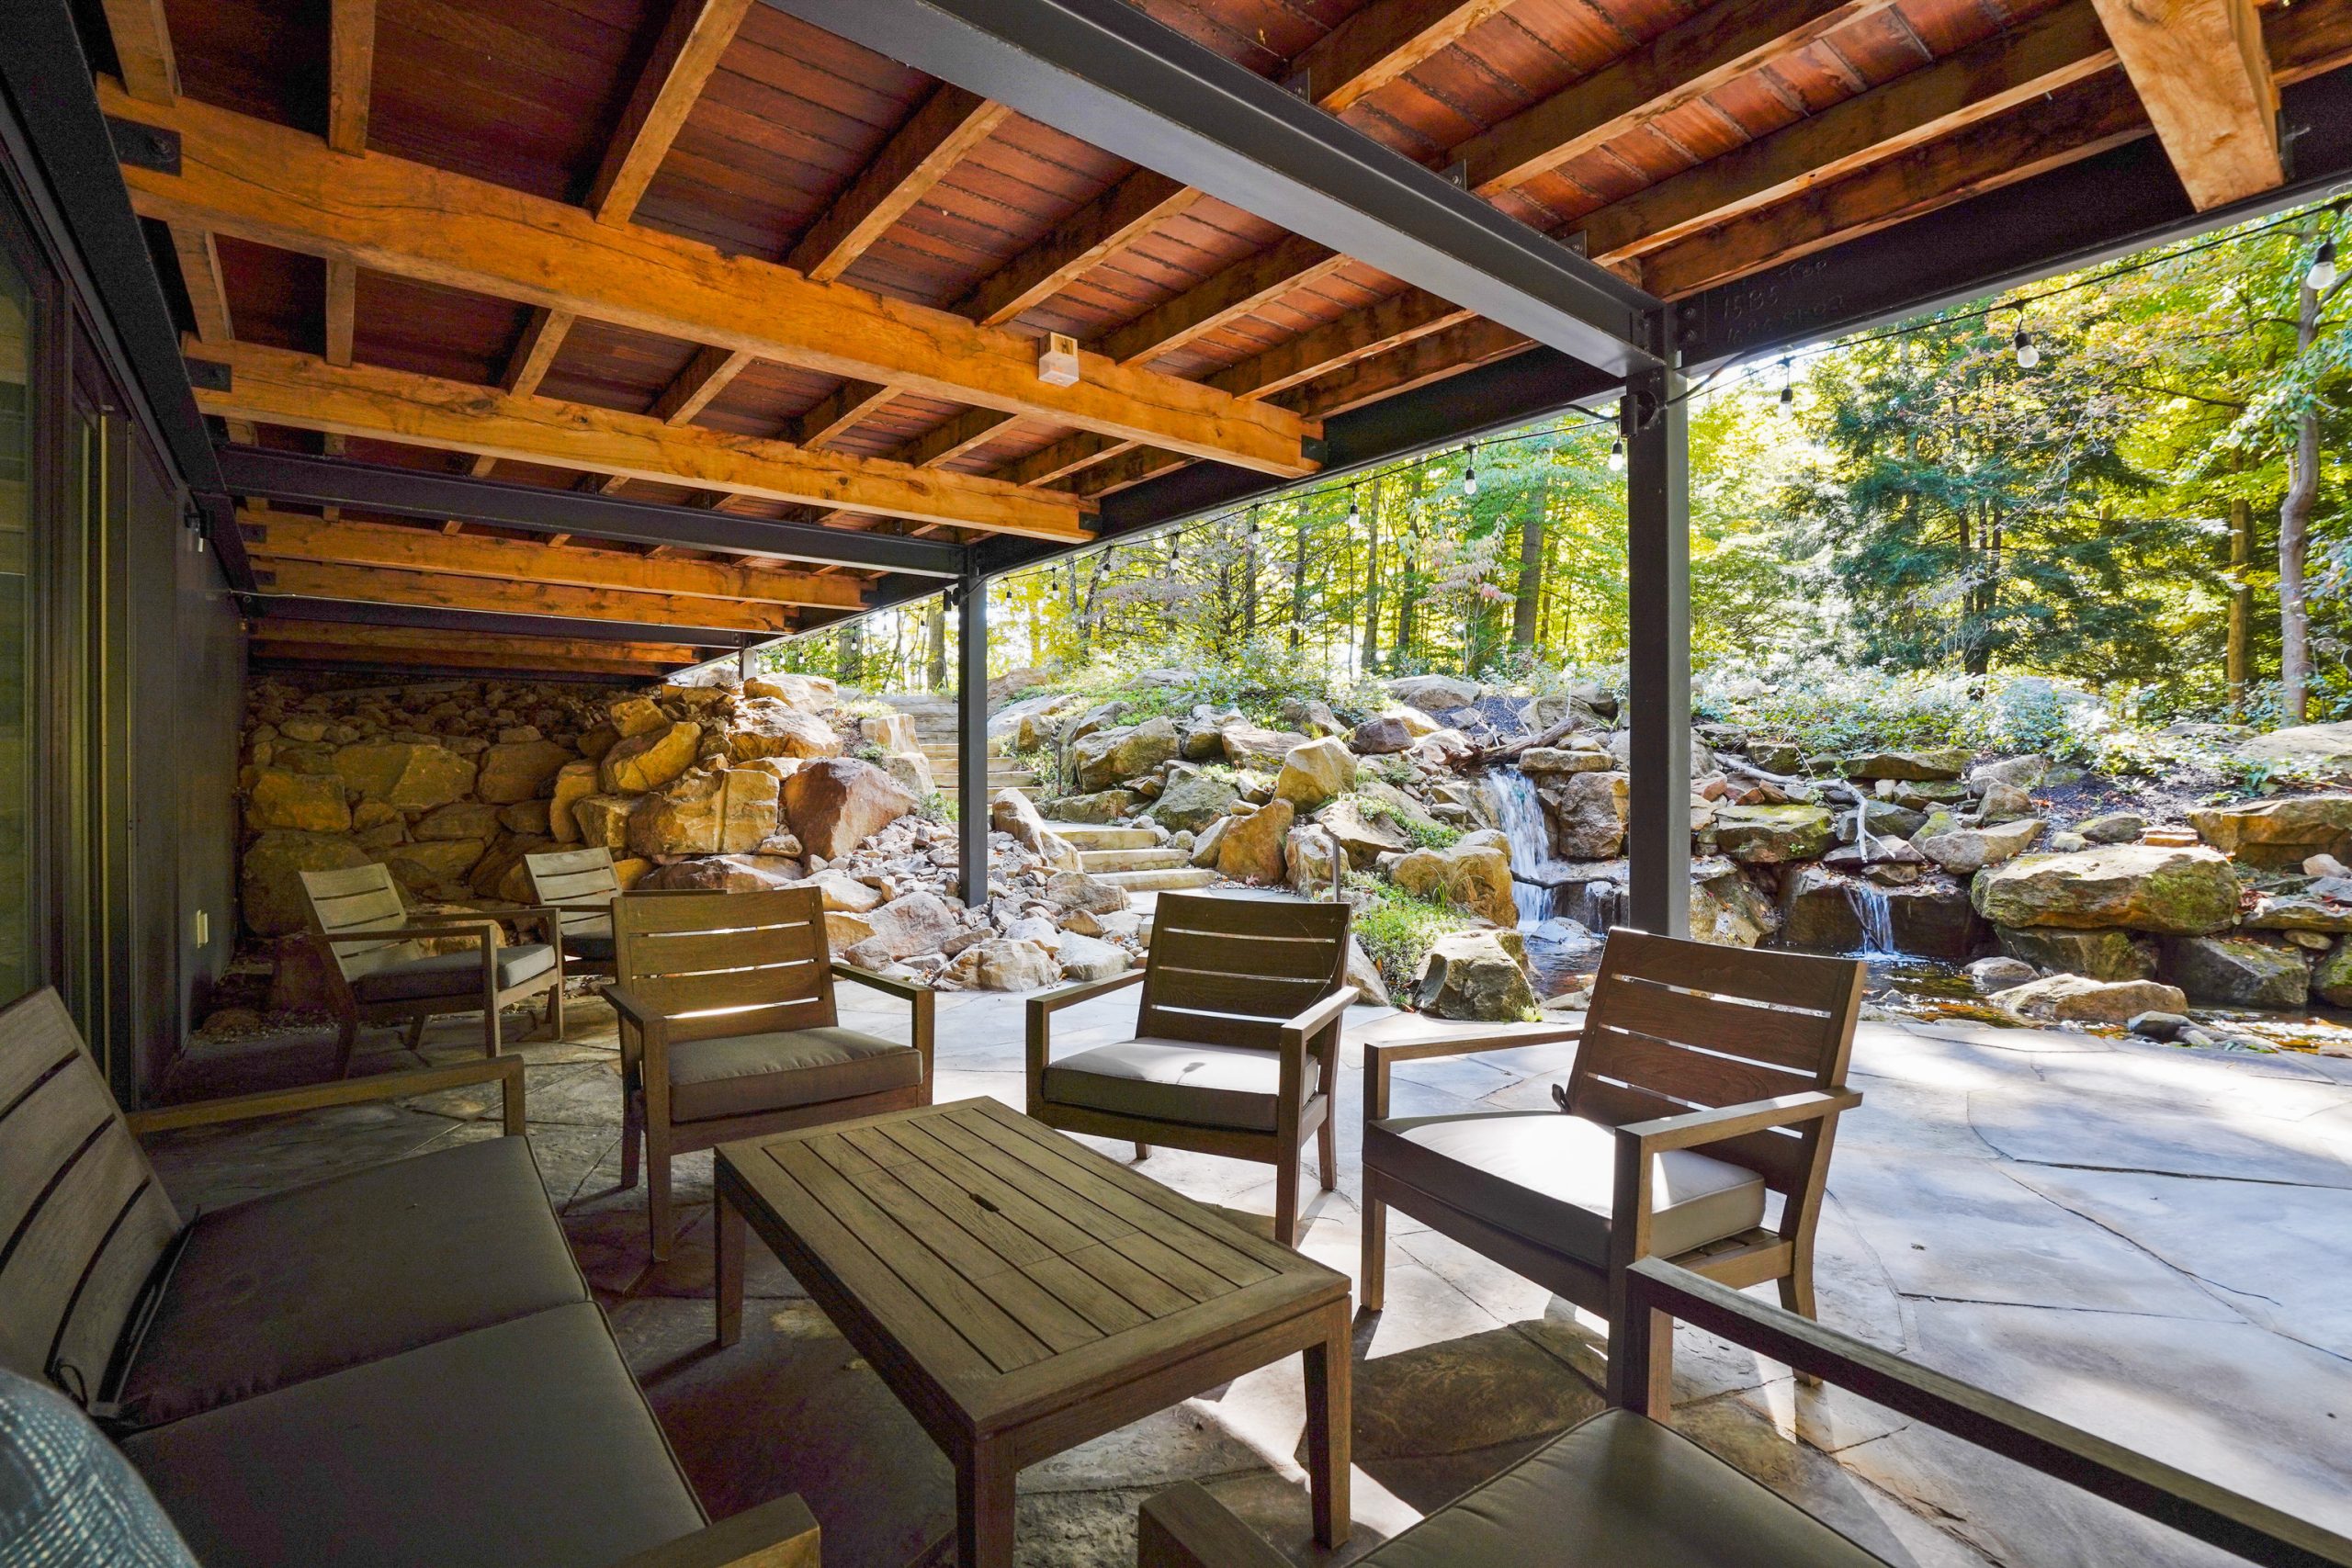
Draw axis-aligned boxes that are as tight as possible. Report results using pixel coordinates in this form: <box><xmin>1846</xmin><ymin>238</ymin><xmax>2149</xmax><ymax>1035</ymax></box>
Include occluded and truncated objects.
<box><xmin>0</xmin><ymin>989</ymin><xmax>819</xmax><ymax>1568</ymax></box>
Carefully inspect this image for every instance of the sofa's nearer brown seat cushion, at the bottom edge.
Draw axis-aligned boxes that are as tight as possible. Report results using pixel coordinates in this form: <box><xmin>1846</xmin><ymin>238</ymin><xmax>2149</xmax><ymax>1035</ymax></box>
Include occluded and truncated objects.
<box><xmin>122</xmin><ymin>1303</ymin><xmax>703</xmax><ymax>1568</ymax></box>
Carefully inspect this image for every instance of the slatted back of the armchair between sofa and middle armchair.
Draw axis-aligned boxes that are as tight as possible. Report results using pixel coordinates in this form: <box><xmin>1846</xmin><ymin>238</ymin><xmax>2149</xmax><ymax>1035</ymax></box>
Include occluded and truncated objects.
<box><xmin>612</xmin><ymin>888</ymin><xmax>840</xmax><ymax>1042</ymax></box>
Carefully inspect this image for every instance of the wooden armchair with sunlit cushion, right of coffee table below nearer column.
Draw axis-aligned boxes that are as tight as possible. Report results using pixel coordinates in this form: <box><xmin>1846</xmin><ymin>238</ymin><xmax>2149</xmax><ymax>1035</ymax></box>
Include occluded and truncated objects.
<box><xmin>1360</xmin><ymin>929</ymin><xmax>1863</xmax><ymax>1392</ymax></box>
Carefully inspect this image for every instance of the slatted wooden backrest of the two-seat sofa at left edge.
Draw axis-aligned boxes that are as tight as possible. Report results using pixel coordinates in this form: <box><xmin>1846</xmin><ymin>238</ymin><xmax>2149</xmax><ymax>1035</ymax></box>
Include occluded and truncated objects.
<box><xmin>0</xmin><ymin>989</ymin><xmax>179</xmax><ymax>1404</ymax></box>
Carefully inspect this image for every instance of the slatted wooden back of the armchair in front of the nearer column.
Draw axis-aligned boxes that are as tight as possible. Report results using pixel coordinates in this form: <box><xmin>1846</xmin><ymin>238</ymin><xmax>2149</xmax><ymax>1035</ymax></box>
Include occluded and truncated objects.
<box><xmin>1569</xmin><ymin>929</ymin><xmax>1865</xmax><ymax>1194</ymax></box>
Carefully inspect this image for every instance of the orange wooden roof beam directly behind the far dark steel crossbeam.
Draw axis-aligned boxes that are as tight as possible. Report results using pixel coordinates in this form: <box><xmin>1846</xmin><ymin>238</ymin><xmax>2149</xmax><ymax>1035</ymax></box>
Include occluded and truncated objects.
<box><xmin>238</xmin><ymin>505</ymin><xmax>865</xmax><ymax>609</ymax></box>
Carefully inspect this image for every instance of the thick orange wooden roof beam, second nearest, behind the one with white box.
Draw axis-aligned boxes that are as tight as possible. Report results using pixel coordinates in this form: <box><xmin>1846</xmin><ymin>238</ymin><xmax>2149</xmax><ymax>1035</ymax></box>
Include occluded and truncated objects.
<box><xmin>190</xmin><ymin>344</ymin><xmax>1087</xmax><ymax>541</ymax></box>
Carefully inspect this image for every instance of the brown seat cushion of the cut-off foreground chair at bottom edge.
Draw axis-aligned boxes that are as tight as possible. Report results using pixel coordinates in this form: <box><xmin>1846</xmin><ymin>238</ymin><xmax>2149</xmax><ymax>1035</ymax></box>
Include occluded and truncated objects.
<box><xmin>1364</xmin><ymin>1411</ymin><xmax>1886</xmax><ymax>1568</ymax></box>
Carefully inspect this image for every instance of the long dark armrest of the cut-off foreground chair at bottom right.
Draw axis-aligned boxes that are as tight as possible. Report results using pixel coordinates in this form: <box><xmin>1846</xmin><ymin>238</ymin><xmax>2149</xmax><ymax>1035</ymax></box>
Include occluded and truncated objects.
<box><xmin>1618</xmin><ymin>1258</ymin><xmax>2352</xmax><ymax>1568</ymax></box>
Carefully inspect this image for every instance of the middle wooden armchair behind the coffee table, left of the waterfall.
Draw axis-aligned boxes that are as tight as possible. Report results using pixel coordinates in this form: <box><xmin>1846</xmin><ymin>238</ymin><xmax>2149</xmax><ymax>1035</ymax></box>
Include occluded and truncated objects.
<box><xmin>1028</xmin><ymin>894</ymin><xmax>1355</xmax><ymax>1246</ymax></box>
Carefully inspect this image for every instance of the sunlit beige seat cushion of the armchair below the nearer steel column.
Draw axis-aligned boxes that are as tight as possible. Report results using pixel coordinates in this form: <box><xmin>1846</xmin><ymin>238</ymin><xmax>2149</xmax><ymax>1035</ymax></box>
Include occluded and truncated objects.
<box><xmin>1364</xmin><ymin>1110</ymin><xmax>1764</xmax><ymax>1267</ymax></box>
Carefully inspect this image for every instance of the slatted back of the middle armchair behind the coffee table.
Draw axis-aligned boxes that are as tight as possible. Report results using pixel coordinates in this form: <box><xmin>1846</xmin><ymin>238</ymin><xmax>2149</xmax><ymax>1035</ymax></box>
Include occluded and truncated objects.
<box><xmin>1136</xmin><ymin>894</ymin><xmax>1352</xmax><ymax>1051</ymax></box>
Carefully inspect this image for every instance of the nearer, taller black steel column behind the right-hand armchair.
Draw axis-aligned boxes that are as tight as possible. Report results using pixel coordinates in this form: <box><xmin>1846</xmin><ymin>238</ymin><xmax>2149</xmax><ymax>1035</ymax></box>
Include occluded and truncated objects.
<box><xmin>1625</xmin><ymin>329</ymin><xmax>1691</xmax><ymax>936</ymax></box>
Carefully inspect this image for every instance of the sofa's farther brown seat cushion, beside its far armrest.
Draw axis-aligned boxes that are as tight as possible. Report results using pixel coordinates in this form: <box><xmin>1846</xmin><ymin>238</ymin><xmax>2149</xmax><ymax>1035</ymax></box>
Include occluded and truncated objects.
<box><xmin>120</xmin><ymin>1138</ymin><xmax>588</xmax><ymax>1427</ymax></box>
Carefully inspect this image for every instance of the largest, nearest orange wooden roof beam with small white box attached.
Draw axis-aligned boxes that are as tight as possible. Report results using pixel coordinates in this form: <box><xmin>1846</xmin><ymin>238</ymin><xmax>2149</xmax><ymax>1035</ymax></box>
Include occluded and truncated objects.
<box><xmin>101</xmin><ymin>80</ymin><xmax>1315</xmax><ymax>478</ymax></box>
